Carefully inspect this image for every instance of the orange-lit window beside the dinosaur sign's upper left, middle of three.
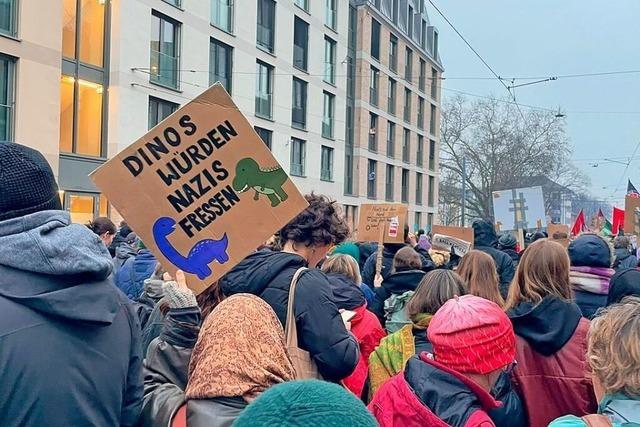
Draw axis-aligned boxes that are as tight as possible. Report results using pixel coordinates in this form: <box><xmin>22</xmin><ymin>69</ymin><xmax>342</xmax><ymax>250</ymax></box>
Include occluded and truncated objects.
<box><xmin>60</xmin><ymin>75</ymin><xmax>104</xmax><ymax>157</ymax></box>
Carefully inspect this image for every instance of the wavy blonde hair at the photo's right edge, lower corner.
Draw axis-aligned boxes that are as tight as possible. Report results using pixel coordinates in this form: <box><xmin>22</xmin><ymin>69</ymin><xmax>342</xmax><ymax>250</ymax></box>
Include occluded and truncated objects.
<box><xmin>587</xmin><ymin>297</ymin><xmax>640</xmax><ymax>397</ymax></box>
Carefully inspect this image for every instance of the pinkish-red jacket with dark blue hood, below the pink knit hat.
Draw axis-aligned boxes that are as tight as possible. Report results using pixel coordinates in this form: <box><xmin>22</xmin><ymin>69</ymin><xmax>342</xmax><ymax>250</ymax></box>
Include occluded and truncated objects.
<box><xmin>369</xmin><ymin>353</ymin><xmax>500</xmax><ymax>427</ymax></box>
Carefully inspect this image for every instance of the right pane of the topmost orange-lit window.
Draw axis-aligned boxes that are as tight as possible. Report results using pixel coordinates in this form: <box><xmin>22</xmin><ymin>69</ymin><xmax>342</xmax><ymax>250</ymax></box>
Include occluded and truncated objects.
<box><xmin>80</xmin><ymin>0</ymin><xmax>106</xmax><ymax>67</ymax></box>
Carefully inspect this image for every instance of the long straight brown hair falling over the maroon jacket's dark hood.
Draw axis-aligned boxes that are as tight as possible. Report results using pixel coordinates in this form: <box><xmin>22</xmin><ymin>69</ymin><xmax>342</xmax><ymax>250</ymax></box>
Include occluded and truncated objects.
<box><xmin>506</xmin><ymin>239</ymin><xmax>573</xmax><ymax>310</ymax></box>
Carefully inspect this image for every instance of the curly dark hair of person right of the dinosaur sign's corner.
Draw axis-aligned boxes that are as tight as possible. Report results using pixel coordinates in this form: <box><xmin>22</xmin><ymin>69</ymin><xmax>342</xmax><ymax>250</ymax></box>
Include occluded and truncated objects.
<box><xmin>280</xmin><ymin>193</ymin><xmax>350</xmax><ymax>246</ymax></box>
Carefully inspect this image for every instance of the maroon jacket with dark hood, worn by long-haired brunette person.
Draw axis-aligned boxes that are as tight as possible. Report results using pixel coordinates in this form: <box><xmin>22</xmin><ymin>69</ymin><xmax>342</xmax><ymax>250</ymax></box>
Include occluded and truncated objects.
<box><xmin>508</xmin><ymin>296</ymin><xmax>597</xmax><ymax>427</ymax></box>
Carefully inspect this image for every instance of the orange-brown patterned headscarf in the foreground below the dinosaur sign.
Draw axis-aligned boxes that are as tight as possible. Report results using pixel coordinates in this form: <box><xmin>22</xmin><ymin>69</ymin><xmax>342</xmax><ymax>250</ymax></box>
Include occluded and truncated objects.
<box><xmin>186</xmin><ymin>294</ymin><xmax>295</xmax><ymax>401</ymax></box>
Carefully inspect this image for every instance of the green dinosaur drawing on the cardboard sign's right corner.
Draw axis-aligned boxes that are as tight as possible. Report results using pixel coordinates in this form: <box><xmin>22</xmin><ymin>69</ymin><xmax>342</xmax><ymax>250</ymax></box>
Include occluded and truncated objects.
<box><xmin>233</xmin><ymin>157</ymin><xmax>289</xmax><ymax>207</ymax></box>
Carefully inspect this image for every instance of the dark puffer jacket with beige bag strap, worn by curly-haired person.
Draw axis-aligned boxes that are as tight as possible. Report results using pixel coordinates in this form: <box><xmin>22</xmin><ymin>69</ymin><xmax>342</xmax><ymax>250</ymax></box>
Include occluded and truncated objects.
<box><xmin>220</xmin><ymin>251</ymin><xmax>360</xmax><ymax>381</ymax></box>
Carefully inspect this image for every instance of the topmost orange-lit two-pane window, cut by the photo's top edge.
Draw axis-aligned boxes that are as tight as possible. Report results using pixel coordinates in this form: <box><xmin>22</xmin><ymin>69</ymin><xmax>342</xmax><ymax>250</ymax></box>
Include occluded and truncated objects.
<box><xmin>62</xmin><ymin>0</ymin><xmax>106</xmax><ymax>67</ymax></box>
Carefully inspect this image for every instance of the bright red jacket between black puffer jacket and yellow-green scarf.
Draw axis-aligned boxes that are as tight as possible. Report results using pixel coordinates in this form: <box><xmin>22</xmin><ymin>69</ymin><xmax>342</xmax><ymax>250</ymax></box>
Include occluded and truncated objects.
<box><xmin>342</xmin><ymin>304</ymin><xmax>387</xmax><ymax>397</ymax></box>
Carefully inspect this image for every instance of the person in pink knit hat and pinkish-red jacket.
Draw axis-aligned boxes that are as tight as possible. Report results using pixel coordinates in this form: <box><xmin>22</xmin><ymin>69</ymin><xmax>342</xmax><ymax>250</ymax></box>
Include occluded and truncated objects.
<box><xmin>369</xmin><ymin>295</ymin><xmax>520</xmax><ymax>427</ymax></box>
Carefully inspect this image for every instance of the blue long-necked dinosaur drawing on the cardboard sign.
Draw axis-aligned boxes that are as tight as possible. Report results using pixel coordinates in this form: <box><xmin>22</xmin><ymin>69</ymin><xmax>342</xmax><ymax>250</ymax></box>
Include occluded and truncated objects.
<box><xmin>153</xmin><ymin>217</ymin><xmax>229</xmax><ymax>280</ymax></box>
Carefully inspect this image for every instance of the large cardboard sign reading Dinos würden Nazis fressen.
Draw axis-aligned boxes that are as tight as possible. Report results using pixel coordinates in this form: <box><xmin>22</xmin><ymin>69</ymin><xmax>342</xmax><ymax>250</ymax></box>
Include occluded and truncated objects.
<box><xmin>91</xmin><ymin>84</ymin><xmax>307</xmax><ymax>293</ymax></box>
